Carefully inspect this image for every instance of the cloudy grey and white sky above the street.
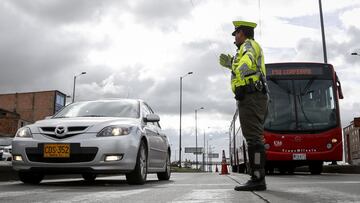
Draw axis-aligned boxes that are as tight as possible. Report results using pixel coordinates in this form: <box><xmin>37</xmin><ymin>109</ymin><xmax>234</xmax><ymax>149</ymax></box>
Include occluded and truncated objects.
<box><xmin>0</xmin><ymin>0</ymin><xmax>360</xmax><ymax>162</ymax></box>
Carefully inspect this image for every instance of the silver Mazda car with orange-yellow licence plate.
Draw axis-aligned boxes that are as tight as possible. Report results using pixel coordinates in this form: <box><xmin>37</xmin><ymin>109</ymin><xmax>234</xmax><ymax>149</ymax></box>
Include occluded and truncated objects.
<box><xmin>12</xmin><ymin>99</ymin><xmax>171</xmax><ymax>184</ymax></box>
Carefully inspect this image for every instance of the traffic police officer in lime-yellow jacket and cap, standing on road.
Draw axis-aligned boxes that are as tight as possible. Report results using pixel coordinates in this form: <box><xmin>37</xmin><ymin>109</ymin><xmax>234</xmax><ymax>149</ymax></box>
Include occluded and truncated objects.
<box><xmin>220</xmin><ymin>21</ymin><xmax>268</xmax><ymax>191</ymax></box>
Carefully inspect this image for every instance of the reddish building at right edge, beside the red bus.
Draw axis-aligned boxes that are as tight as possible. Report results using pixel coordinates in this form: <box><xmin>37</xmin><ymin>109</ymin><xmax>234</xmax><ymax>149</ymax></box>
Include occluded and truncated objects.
<box><xmin>344</xmin><ymin>118</ymin><xmax>360</xmax><ymax>165</ymax></box>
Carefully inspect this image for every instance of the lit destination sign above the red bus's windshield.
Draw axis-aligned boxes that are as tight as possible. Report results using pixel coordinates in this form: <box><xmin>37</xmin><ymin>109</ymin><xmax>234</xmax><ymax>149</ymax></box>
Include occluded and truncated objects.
<box><xmin>268</xmin><ymin>67</ymin><xmax>323</xmax><ymax>76</ymax></box>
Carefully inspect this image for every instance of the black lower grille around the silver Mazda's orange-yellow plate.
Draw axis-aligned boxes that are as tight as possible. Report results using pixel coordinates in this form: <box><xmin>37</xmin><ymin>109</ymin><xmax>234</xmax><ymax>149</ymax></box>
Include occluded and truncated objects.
<box><xmin>25</xmin><ymin>143</ymin><xmax>98</xmax><ymax>163</ymax></box>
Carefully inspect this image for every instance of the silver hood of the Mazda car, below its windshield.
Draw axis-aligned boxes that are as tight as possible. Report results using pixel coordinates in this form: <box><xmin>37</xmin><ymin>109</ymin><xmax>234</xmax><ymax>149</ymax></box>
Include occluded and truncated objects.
<box><xmin>27</xmin><ymin>117</ymin><xmax>141</xmax><ymax>133</ymax></box>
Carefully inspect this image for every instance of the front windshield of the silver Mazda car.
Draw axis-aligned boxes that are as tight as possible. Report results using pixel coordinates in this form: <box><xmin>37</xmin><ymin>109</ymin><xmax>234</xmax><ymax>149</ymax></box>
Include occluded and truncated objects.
<box><xmin>54</xmin><ymin>100</ymin><xmax>140</xmax><ymax>118</ymax></box>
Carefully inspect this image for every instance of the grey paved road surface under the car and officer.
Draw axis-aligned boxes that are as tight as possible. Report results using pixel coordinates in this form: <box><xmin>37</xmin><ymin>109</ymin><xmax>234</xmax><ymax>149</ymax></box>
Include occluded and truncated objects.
<box><xmin>0</xmin><ymin>173</ymin><xmax>360</xmax><ymax>203</ymax></box>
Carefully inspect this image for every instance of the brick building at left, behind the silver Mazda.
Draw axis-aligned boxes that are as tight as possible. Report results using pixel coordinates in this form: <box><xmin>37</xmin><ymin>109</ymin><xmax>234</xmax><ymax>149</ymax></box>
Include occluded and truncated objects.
<box><xmin>0</xmin><ymin>90</ymin><xmax>66</xmax><ymax>137</ymax></box>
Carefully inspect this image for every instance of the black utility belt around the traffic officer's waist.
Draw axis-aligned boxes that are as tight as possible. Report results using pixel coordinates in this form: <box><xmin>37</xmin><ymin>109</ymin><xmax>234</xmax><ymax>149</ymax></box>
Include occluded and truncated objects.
<box><xmin>235</xmin><ymin>77</ymin><xmax>268</xmax><ymax>100</ymax></box>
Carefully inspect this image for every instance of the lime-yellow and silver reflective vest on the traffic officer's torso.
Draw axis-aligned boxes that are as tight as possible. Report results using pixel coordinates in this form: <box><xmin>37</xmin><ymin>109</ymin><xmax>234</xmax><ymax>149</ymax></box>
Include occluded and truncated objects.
<box><xmin>231</xmin><ymin>39</ymin><xmax>266</xmax><ymax>93</ymax></box>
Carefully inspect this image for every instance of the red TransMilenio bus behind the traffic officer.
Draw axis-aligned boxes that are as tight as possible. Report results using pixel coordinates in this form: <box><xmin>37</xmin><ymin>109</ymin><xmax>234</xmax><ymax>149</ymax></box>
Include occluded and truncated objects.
<box><xmin>229</xmin><ymin>63</ymin><xmax>343</xmax><ymax>174</ymax></box>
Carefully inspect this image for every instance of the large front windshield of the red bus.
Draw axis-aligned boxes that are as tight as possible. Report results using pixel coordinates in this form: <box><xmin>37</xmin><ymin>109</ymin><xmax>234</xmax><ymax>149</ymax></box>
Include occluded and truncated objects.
<box><xmin>265</xmin><ymin>77</ymin><xmax>337</xmax><ymax>132</ymax></box>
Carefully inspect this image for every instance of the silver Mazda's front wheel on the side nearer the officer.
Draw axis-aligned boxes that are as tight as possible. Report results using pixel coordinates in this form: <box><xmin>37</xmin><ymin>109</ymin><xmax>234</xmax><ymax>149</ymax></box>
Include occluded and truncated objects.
<box><xmin>126</xmin><ymin>141</ymin><xmax>148</xmax><ymax>185</ymax></box>
